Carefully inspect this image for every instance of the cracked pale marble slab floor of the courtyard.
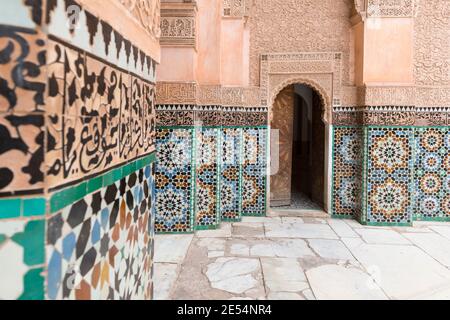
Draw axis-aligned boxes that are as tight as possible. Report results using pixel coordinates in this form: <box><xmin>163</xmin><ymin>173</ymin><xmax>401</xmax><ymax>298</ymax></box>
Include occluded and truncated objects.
<box><xmin>154</xmin><ymin>211</ymin><xmax>450</xmax><ymax>300</ymax></box>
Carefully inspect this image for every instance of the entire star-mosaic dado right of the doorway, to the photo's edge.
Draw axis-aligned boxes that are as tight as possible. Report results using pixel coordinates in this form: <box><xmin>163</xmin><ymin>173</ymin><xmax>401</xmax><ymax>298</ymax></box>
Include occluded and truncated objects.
<box><xmin>333</xmin><ymin>126</ymin><xmax>450</xmax><ymax>225</ymax></box>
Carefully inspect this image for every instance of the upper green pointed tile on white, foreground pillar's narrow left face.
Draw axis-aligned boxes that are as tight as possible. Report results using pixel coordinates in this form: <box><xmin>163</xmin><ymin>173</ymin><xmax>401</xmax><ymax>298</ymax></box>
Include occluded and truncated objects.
<box><xmin>11</xmin><ymin>220</ymin><xmax>45</xmax><ymax>266</ymax></box>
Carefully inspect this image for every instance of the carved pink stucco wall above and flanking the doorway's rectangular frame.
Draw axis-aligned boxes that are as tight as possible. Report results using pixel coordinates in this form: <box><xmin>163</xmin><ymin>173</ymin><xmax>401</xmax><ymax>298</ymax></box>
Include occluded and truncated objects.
<box><xmin>249</xmin><ymin>0</ymin><xmax>354</xmax><ymax>86</ymax></box>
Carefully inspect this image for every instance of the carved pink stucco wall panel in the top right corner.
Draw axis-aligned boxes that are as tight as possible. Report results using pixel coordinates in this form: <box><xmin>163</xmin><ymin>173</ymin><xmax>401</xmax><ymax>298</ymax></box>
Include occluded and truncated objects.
<box><xmin>414</xmin><ymin>0</ymin><xmax>450</xmax><ymax>87</ymax></box>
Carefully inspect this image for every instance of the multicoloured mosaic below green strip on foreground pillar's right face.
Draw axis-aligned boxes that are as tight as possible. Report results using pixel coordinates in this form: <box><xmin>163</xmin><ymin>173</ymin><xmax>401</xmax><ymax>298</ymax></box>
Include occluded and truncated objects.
<box><xmin>47</xmin><ymin>164</ymin><xmax>154</xmax><ymax>300</ymax></box>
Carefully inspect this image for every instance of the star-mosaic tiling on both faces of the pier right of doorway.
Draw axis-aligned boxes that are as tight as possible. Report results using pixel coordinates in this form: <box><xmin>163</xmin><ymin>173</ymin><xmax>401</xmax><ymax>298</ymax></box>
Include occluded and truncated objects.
<box><xmin>333</xmin><ymin>126</ymin><xmax>414</xmax><ymax>226</ymax></box>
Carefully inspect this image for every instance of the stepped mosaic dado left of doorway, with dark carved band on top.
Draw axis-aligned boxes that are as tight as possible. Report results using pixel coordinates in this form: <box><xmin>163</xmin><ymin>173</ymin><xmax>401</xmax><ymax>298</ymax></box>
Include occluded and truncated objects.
<box><xmin>155</xmin><ymin>105</ymin><xmax>268</xmax><ymax>233</ymax></box>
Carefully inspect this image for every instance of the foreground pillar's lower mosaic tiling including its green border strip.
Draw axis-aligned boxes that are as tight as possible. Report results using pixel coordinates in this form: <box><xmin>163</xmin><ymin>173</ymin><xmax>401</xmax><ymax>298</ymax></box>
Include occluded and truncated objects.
<box><xmin>0</xmin><ymin>153</ymin><xmax>155</xmax><ymax>299</ymax></box>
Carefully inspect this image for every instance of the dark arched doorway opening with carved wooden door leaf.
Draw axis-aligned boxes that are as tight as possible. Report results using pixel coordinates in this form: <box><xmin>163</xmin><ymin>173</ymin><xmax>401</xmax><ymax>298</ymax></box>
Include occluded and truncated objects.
<box><xmin>270</xmin><ymin>83</ymin><xmax>328</xmax><ymax>211</ymax></box>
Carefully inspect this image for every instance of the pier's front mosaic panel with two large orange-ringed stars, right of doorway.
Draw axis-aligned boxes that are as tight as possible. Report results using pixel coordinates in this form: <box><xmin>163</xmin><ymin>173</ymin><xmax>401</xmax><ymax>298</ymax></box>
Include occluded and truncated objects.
<box><xmin>366</xmin><ymin>127</ymin><xmax>414</xmax><ymax>225</ymax></box>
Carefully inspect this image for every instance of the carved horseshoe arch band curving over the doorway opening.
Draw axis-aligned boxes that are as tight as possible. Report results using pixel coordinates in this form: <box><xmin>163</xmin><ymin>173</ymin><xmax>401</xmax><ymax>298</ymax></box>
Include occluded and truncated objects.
<box><xmin>269</xmin><ymin>76</ymin><xmax>333</xmax><ymax>124</ymax></box>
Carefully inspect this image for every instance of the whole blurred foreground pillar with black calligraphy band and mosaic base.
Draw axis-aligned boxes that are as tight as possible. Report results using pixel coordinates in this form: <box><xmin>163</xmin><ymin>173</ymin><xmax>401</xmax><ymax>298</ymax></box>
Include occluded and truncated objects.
<box><xmin>0</xmin><ymin>0</ymin><xmax>159</xmax><ymax>300</ymax></box>
